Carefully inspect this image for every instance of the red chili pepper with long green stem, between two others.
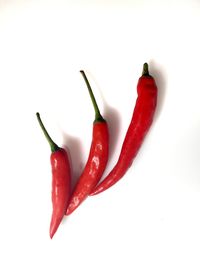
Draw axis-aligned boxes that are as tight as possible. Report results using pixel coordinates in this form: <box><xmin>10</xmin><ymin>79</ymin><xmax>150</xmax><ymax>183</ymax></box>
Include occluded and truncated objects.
<box><xmin>66</xmin><ymin>71</ymin><xmax>109</xmax><ymax>215</ymax></box>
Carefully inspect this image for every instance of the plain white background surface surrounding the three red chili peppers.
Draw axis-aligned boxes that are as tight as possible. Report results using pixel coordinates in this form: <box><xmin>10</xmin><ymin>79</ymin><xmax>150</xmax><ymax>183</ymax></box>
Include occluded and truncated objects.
<box><xmin>0</xmin><ymin>0</ymin><xmax>200</xmax><ymax>267</ymax></box>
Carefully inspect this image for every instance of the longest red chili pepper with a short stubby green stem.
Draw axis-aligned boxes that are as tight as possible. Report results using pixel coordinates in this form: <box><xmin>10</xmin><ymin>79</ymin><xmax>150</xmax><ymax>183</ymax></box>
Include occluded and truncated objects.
<box><xmin>90</xmin><ymin>63</ymin><xmax>157</xmax><ymax>196</ymax></box>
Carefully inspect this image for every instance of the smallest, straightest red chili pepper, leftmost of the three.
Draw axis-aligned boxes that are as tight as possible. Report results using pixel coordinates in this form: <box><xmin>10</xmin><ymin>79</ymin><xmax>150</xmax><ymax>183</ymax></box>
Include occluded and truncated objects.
<box><xmin>36</xmin><ymin>113</ymin><xmax>71</xmax><ymax>238</ymax></box>
